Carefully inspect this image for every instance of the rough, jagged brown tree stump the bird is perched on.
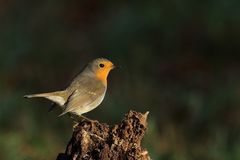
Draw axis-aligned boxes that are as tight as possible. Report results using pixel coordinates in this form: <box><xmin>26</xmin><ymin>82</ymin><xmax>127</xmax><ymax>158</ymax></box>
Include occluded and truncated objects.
<box><xmin>57</xmin><ymin>111</ymin><xmax>150</xmax><ymax>160</ymax></box>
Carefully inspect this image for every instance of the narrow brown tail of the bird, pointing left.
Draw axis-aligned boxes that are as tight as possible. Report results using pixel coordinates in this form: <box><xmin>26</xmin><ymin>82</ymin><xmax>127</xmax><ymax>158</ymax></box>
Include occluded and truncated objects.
<box><xmin>24</xmin><ymin>91</ymin><xmax>67</xmax><ymax>106</ymax></box>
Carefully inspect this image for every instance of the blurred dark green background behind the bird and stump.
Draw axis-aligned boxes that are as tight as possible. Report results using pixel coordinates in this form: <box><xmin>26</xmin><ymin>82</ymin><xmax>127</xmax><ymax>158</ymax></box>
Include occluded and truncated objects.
<box><xmin>0</xmin><ymin>0</ymin><xmax>240</xmax><ymax>160</ymax></box>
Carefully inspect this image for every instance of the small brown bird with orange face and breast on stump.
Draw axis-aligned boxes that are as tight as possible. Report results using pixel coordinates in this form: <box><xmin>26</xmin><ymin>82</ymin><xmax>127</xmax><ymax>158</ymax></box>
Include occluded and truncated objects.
<box><xmin>24</xmin><ymin>58</ymin><xmax>115</xmax><ymax>118</ymax></box>
